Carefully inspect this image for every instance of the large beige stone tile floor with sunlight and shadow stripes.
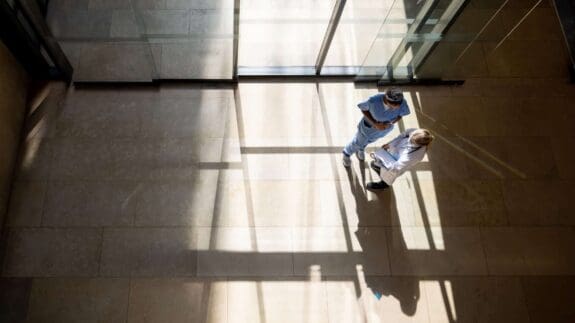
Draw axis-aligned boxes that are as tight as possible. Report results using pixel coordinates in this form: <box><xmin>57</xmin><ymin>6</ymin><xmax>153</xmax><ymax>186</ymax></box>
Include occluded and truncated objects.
<box><xmin>0</xmin><ymin>78</ymin><xmax>575</xmax><ymax>323</ymax></box>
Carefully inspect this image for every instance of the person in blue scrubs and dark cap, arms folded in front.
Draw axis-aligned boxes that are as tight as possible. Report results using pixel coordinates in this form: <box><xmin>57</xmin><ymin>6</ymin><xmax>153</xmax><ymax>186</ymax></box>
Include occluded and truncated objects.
<box><xmin>343</xmin><ymin>87</ymin><xmax>410</xmax><ymax>167</ymax></box>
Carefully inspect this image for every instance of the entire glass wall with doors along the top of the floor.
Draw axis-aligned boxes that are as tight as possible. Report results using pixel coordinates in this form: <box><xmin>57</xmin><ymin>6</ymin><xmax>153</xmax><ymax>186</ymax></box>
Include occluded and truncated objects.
<box><xmin>42</xmin><ymin>0</ymin><xmax>549</xmax><ymax>81</ymax></box>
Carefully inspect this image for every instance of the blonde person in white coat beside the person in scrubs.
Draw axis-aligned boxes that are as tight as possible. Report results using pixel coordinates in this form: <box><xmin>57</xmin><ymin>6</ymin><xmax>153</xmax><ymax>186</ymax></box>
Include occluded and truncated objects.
<box><xmin>367</xmin><ymin>129</ymin><xmax>434</xmax><ymax>190</ymax></box>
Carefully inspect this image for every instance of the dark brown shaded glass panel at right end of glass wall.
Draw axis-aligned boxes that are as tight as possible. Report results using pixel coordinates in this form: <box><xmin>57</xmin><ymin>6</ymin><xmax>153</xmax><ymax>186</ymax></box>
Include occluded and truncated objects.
<box><xmin>412</xmin><ymin>0</ymin><xmax>542</xmax><ymax>80</ymax></box>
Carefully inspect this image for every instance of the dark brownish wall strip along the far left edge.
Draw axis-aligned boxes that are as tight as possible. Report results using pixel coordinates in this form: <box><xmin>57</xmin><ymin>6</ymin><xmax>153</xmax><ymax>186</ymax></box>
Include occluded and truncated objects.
<box><xmin>0</xmin><ymin>41</ymin><xmax>28</xmax><ymax>233</ymax></box>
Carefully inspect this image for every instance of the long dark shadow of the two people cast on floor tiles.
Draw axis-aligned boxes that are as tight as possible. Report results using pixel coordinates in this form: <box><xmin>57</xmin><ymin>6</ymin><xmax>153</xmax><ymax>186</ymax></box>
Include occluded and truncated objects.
<box><xmin>347</xmin><ymin>169</ymin><xmax>420</xmax><ymax>316</ymax></box>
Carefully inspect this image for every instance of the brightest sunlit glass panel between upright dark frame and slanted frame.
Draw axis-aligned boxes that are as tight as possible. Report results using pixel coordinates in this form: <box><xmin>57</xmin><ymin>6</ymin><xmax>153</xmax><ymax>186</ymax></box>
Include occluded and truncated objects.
<box><xmin>239</xmin><ymin>0</ymin><xmax>335</xmax><ymax>75</ymax></box>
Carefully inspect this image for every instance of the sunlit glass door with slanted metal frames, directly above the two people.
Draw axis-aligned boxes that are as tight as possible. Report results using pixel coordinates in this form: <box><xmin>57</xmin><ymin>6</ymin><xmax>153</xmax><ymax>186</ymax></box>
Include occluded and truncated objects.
<box><xmin>321</xmin><ymin>0</ymin><xmax>467</xmax><ymax>80</ymax></box>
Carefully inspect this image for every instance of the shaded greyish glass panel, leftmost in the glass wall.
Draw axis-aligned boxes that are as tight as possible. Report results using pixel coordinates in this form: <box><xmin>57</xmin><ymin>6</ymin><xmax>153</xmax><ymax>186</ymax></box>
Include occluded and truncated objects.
<box><xmin>47</xmin><ymin>0</ymin><xmax>234</xmax><ymax>81</ymax></box>
